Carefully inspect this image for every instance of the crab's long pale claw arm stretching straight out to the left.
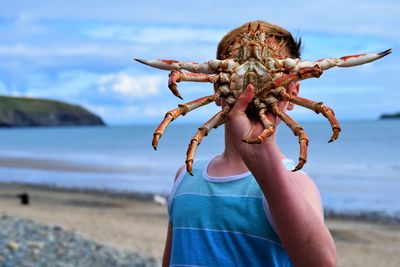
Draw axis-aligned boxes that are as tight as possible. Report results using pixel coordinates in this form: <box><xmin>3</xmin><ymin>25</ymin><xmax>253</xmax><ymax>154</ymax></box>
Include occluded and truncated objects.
<box><xmin>135</xmin><ymin>58</ymin><xmax>239</xmax><ymax>74</ymax></box>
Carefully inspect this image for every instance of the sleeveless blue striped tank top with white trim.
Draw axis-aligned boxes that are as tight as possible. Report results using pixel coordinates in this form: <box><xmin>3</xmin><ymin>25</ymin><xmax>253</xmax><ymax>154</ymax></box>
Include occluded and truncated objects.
<box><xmin>168</xmin><ymin>159</ymin><xmax>294</xmax><ymax>267</ymax></box>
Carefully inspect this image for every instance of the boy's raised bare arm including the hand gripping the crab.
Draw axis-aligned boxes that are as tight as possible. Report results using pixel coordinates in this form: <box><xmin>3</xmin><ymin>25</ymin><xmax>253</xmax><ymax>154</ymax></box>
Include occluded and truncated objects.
<box><xmin>225</xmin><ymin>84</ymin><xmax>336</xmax><ymax>267</ymax></box>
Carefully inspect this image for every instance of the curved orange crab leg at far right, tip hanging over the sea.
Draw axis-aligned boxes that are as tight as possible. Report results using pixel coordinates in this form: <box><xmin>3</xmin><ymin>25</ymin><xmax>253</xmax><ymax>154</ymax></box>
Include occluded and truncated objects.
<box><xmin>285</xmin><ymin>93</ymin><xmax>341</xmax><ymax>143</ymax></box>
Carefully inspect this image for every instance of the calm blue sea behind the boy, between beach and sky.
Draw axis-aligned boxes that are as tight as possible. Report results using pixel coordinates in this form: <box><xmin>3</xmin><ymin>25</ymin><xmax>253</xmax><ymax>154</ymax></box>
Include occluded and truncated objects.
<box><xmin>0</xmin><ymin>120</ymin><xmax>400</xmax><ymax>218</ymax></box>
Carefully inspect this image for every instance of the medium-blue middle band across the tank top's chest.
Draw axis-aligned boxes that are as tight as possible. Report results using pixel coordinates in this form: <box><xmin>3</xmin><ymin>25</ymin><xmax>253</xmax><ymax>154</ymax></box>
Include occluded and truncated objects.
<box><xmin>171</xmin><ymin>194</ymin><xmax>280</xmax><ymax>244</ymax></box>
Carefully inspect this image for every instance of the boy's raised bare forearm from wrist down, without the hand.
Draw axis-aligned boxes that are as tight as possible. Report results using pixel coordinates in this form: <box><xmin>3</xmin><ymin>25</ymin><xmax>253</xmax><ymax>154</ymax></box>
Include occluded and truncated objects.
<box><xmin>242</xmin><ymin>142</ymin><xmax>335</xmax><ymax>266</ymax></box>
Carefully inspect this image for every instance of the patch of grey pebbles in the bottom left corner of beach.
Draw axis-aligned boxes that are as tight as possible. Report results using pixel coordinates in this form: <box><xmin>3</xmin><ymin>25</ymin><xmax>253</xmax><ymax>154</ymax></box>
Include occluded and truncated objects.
<box><xmin>0</xmin><ymin>217</ymin><xmax>160</xmax><ymax>267</ymax></box>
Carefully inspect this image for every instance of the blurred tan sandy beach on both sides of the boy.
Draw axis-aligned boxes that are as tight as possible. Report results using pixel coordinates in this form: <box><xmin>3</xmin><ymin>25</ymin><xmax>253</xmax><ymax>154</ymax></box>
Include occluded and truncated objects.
<box><xmin>0</xmin><ymin>184</ymin><xmax>400</xmax><ymax>267</ymax></box>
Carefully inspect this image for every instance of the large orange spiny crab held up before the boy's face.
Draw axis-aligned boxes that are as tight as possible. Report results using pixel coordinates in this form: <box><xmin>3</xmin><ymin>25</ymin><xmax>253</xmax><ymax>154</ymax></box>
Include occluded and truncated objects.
<box><xmin>135</xmin><ymin>23</ymin><xmax>391</xmax><ymax>175</ymax></box>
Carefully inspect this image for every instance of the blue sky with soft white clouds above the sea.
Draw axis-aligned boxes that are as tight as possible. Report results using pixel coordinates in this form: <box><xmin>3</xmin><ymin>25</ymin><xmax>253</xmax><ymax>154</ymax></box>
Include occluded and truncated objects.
<box><xmin>0</xmin><ymin>0</ymin><xmax>400</xmax><ymax>125</ymax></box>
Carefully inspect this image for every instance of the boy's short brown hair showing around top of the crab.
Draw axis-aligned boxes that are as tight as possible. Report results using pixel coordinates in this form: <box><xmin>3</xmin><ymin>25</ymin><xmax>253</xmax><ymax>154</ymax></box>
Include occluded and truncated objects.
<box><xmin>217</xmin><ymin>20</ymin><xmax>301</xmax><ymax>59</ymax></box>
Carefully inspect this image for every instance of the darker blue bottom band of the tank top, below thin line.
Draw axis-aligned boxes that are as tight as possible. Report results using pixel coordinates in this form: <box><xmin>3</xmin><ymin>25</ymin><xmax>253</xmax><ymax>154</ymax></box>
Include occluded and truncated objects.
<box><xmin>171</xmin><ymin>228</ymin><xmax>292</xmax><ymax>267</ymax></box>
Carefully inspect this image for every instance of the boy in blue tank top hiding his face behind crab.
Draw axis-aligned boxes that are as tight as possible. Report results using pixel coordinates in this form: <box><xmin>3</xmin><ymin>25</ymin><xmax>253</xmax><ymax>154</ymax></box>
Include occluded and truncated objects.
<box><xmin>163</xmin><ymin>21</ymin><xmax>336</xmax><ymax>267</ymax></box>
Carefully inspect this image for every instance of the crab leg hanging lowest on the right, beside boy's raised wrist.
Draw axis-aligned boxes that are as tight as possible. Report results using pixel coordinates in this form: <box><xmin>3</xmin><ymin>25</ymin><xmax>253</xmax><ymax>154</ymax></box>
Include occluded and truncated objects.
<box><xmin>270</xmin><ymin>102</ymin><xmax>308</xmax><ymax>171</ymax></box>
